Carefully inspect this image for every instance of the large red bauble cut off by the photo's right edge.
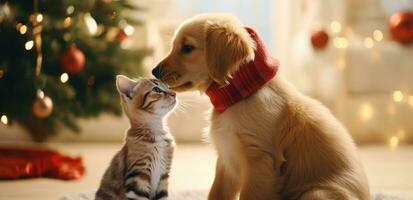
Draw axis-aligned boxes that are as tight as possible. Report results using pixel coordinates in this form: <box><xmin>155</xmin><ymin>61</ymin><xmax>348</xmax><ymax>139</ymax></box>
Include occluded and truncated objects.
<box><xmin>389</xmin><ymin>11</ymin><xmax>413</xmax><ymax>44</ymax></box>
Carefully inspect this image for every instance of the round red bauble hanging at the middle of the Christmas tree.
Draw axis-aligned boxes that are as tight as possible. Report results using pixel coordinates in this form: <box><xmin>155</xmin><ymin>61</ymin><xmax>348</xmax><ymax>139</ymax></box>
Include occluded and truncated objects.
<box><xmin>60</xmin><ymin>44</ymin><xmax>85</xmax><ymax>74</ymax></box>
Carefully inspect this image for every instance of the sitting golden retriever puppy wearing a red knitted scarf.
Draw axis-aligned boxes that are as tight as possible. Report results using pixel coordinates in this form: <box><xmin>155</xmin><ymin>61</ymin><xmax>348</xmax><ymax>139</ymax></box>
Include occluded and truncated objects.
<box><xmin>152</xmin><ymin>14</ymin><xmax>370</xmax><ymax>200</ymax></box>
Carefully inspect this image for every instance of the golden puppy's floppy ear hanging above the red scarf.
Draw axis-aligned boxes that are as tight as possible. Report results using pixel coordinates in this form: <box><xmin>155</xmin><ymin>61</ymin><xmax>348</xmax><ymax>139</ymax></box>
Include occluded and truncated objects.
<box><xmin>205</xmin><ymin>17</ymin><xmax>255</xmax><ymax>85</ymax></box>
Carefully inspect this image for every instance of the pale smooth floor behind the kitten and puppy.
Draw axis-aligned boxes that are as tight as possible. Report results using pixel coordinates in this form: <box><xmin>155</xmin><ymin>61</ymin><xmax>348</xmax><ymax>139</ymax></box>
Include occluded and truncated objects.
<box><xmin>0</xmin><ymin>143</ymin><xmax>413</xmax><ymax>200</ymax></box>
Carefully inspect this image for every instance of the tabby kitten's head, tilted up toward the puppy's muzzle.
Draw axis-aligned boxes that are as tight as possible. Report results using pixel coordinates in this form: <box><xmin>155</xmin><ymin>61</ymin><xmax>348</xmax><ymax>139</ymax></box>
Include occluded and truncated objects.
<box><xmin>116</xmin><ymin>75</ymin><xmax>176</xmax><ymax>120</ymax></box>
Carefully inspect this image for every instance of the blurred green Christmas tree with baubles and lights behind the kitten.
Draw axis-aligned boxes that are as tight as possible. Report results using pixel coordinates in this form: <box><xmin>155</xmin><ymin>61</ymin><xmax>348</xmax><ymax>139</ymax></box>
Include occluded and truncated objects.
<box><xmin>0</xmin><ymin>0</ymin><xmax>149</xmax><ymax>141</ymax></box>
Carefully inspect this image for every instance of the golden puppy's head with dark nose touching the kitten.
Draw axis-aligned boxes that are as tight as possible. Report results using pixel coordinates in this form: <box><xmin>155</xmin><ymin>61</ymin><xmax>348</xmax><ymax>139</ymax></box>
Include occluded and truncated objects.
<box><xmin>152</xmin><ymin>14</ymin><xmax>255</xmax><ymax>91</ymax></box>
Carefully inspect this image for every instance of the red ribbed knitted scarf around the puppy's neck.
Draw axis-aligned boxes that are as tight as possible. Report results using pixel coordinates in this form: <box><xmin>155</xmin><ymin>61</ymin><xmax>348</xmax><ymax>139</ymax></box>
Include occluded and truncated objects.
<box><xmin>205</xmin><ymin>27</ymin><xmax>279</xmax><ymax>113</ymax></box>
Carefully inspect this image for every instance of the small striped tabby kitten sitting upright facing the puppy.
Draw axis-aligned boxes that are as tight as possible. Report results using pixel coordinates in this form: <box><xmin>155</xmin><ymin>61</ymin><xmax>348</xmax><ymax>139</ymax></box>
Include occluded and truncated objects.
<box><xmin>96</xmin><ymin>75</ymin><xmax>176</xmax><ymax>200</ymax></box>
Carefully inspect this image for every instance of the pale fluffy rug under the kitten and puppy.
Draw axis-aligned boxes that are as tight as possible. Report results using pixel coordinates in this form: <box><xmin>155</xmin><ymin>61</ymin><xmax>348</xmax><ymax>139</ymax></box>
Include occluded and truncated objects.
<box><xmin>60</xmin><ymin>191</ymin><xmax>403</xmax><ymax>200</ymax></box>
